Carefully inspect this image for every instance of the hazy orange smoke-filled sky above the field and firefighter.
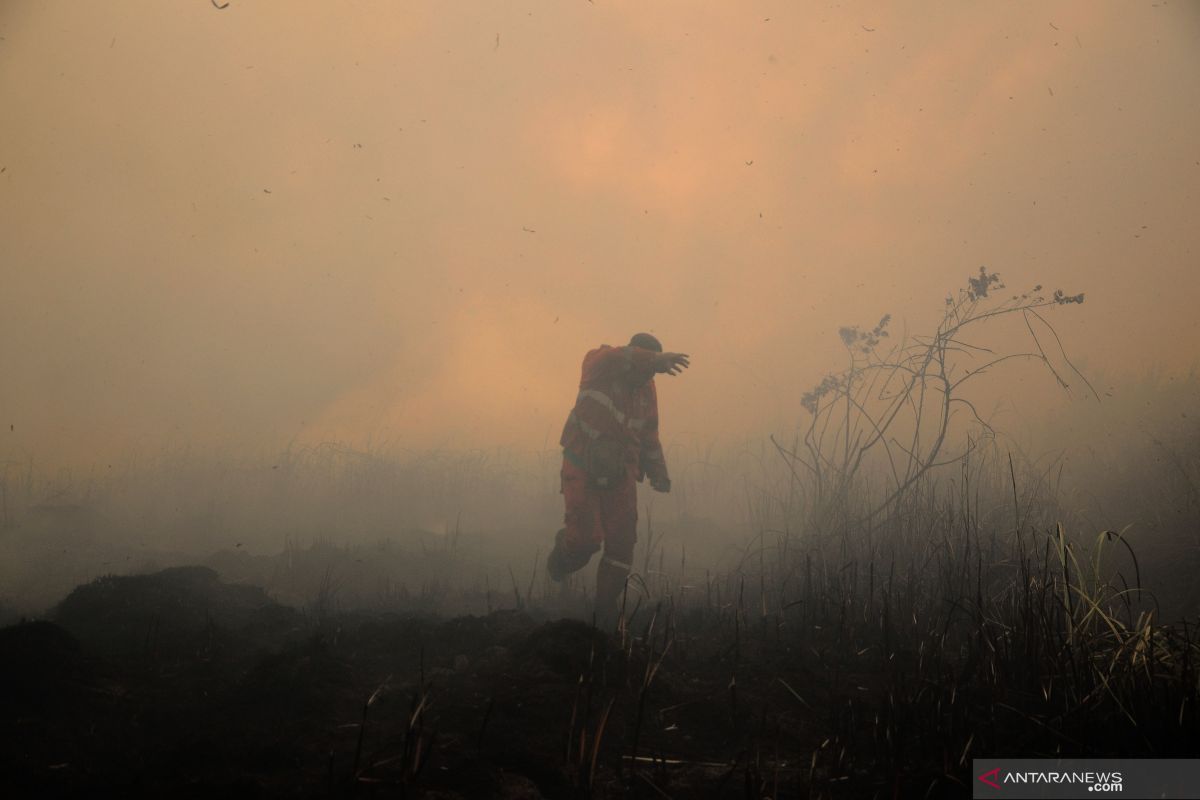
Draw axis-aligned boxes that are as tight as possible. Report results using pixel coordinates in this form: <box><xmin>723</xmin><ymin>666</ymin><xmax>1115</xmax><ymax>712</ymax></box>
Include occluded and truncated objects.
<box><xmin>0</xmin><ymin>0</ymin><xmax>1200</xmax><ymax>464</ymax></box>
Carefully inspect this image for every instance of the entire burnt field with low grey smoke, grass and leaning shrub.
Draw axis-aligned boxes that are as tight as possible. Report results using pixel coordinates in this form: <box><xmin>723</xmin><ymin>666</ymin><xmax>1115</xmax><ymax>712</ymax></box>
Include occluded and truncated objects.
<box><xmin>0</xmin><ymin>286</ymin><xmax>1200</xmax><ymax>799</ymax></box>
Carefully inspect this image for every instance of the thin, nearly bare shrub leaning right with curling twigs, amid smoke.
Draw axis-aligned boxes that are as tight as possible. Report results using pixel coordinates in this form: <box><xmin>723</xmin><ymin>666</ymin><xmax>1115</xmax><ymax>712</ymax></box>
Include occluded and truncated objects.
<box><xmin>772</xmin><ymin>267</ymin><xmax>1098</xmax><ymax>527</ymax></box>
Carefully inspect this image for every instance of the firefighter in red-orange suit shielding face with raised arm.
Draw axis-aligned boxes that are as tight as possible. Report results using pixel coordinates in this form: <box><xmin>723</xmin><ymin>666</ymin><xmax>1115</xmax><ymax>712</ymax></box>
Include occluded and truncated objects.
<box><xmin>546</xmin><ymin>333</ymin><xmax>689</xmax><ymax>621</ymax></box>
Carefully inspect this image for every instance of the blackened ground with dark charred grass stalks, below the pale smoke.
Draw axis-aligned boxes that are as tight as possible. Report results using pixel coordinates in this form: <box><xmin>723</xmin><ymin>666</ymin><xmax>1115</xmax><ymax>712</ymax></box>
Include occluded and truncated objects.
<box><xmin>0</xmin><ymin>462</ymin><xmax>1200</xmax><ymax>798</ymax></box>
